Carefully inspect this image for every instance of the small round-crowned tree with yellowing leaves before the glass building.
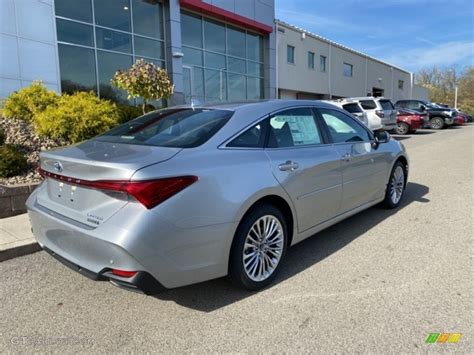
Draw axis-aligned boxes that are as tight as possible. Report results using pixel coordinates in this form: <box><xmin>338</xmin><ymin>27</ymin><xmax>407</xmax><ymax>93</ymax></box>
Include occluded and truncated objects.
<box><xmin>112</xmin><ymin>59</ymin><xmax>174</xmax><ymax>113</ymax></box>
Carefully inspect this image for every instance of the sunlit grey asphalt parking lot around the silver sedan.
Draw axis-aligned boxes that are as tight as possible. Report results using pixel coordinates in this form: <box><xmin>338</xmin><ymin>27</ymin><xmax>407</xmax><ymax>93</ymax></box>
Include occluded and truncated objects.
<box><xmin>0</xmin><ymin>125</ymin><xmax>474</xmax><ymax>353</ymax></box>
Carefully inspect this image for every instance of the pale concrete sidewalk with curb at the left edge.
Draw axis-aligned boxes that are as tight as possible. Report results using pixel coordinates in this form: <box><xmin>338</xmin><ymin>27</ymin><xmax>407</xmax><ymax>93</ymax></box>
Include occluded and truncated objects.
<box><xmin>0</xmin><ymin>213</ymin><xmax>41</xmax><ymax>261</ymax></box>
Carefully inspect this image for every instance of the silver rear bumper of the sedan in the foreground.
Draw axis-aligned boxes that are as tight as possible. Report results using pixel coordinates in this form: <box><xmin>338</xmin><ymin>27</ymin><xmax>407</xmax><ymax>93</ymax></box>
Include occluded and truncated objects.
<box><xmin>27</xmin><ymin>192</ymin><xmax>237</xmax><ymax>292</ymax></box>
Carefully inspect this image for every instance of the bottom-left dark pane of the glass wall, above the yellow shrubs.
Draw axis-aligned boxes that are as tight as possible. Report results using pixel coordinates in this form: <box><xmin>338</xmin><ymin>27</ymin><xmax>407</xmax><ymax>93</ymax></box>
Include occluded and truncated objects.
<box><xmin>58</xmin><ymin>44</ymin><xmax>97</xmax><ymax>93</ymax></box>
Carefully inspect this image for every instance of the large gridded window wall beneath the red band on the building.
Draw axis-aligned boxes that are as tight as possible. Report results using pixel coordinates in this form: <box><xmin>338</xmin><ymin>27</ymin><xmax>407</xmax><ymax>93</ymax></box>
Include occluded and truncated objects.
<box><xmin>181</xmin><ymin>12</ymin><xmax>264</xmax><ymax>103</ymax></box>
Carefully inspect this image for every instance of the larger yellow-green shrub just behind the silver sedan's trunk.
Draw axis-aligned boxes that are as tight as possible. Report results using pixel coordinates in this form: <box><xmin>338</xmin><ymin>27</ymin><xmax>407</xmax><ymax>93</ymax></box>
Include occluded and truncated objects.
<box><xmin>35</xmin><ymin>92</ymin><xmax>119</xmax><ymax>143</ymax></box>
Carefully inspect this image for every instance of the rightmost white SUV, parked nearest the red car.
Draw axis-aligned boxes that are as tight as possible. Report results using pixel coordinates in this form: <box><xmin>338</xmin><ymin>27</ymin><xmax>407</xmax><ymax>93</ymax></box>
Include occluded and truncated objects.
<box><xmin>351</xmin><ymin>96</ymin><xmax>397</xmax><ymax>131</ymax></box>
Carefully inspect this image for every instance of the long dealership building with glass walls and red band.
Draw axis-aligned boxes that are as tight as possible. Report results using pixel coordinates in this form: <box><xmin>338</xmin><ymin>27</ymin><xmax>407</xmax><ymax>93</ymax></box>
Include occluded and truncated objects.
<box><xmin>0</xmin><ymin>0</ymin><xmax>426</xmax><ymax>105</ymax></box>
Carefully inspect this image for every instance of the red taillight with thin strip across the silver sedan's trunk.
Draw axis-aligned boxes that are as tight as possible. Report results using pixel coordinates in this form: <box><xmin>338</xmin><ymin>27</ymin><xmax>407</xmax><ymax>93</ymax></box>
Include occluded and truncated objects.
<box><xmin>38</xmin><ymin>168</ymin><xmax>198</xmax><ymax>209</ymax></box>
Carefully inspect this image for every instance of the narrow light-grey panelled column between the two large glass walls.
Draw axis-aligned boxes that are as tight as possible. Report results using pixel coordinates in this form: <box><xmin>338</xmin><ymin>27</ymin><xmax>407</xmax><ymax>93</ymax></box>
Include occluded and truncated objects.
<box><xmin>164</xmin><ymin>0</ymin><xmax>184</xmax><ymax>106</ymax></box>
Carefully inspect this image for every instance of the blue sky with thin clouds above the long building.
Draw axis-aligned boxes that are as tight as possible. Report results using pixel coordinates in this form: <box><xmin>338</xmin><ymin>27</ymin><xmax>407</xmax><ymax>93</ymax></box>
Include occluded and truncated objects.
<box><xmin>275</xmin><ymin>0</ymin><xmax>474</xmax><ymax>72</ymax></box>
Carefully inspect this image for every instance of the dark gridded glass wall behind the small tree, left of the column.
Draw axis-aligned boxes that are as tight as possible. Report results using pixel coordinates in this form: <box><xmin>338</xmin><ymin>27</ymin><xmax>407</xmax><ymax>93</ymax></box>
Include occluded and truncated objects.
<box><xmin>54</xmin><ymin>0</ymin><xmax>165</xmax><ymax>102</ymax></box>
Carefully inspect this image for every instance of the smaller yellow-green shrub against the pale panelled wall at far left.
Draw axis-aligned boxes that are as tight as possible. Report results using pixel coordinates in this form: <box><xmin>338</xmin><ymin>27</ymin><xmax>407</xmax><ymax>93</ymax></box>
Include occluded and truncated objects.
<box><xmin>3</xmin><ymin>81</ymin><xmax>59</xmax><ymax>122</ymax></box>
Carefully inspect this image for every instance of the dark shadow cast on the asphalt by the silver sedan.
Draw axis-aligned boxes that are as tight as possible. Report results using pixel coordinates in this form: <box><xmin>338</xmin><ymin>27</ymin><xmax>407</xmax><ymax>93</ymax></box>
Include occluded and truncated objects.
<box><xmin>153</xmin><ymin>182</ymin><xmax>430</xmax><ymax>312</ymax></box>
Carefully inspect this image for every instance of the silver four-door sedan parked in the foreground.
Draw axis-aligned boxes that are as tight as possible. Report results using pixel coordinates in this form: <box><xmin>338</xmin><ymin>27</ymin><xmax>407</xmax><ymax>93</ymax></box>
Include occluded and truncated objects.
<box><xmin>27</xmin><ymin>100</ymin><xmax>408</xmax><ymax>293</ymax></box>
